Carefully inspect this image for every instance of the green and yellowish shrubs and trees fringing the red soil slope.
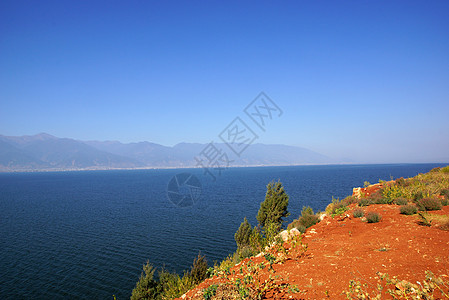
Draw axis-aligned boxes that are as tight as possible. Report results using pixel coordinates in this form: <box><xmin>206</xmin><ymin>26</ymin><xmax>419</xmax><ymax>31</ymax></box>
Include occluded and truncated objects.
<box><xmin>131</xmin><ymin>166</ymin><xmax>449</xmax><ymax>299</ymax></box>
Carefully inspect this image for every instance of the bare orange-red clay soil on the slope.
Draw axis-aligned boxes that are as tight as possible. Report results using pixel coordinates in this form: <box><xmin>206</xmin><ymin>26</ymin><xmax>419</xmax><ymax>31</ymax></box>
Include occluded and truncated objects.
<box><xmin>178</xmin><ymin>204</ymin><xmax>449</xmax><ymax>299</ymax></box>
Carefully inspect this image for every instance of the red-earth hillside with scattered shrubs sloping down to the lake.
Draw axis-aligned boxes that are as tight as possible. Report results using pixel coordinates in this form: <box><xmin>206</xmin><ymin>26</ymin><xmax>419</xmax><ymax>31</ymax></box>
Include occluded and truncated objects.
<box><xmin>174</xmin><ymin>167</ymin><xmax>449</xmax><ymax>299</ymax></box>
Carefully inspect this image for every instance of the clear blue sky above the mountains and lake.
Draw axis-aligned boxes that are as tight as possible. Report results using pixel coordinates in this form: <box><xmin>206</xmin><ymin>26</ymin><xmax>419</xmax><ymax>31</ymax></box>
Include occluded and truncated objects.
<box><xmin>0</xmin><ymin>0</ymin><xmax>449</xmax><ymax>162</ymax></box>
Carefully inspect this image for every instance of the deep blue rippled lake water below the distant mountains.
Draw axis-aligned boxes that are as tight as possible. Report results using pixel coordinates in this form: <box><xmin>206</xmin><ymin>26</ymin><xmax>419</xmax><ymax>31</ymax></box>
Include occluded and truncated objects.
<box><xmin>0</xmin><ymin>164</ymin><xmax>444</xmax><ymax>299</ymax></box>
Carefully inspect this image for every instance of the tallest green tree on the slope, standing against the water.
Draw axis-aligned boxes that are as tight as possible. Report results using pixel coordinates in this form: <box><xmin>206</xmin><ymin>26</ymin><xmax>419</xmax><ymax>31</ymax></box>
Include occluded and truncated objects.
<box><xmin>257</xmin><ymin>181</ymin><xmax>290</xmax><ymax>228</ymax></box>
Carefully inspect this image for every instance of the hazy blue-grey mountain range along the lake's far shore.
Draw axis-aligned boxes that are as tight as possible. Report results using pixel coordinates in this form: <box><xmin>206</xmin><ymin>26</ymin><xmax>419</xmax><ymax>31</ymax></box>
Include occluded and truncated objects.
<box><xmin>0</xmin><ymin>133</ymin><xmax>335</xmax><ymax>171</ymax></box>
